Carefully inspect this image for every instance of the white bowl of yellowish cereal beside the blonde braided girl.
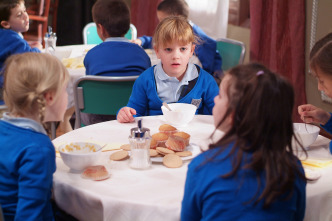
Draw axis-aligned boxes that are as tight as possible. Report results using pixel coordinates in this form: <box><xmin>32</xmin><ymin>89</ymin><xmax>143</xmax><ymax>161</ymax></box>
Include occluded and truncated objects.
<box><xmin>58</xmin><ymin>142</ymin><xmax>102</xmax><ymax>171</ymax></box>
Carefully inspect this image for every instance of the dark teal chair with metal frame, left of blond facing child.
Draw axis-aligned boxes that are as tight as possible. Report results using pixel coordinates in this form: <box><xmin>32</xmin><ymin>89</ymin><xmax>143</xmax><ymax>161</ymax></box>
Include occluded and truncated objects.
<box><xmin>74</xmin><ymin>76</ymin><xmax>138</xmax><ymax>129</ymax></box>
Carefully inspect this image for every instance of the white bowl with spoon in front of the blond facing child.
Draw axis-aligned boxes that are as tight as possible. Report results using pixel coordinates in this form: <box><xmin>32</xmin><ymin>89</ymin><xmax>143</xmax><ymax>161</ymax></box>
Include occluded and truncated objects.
<box><xmin>161</xmin><ymin>103</ymin><xmax>197</xmax><ymax>127</ymax></box>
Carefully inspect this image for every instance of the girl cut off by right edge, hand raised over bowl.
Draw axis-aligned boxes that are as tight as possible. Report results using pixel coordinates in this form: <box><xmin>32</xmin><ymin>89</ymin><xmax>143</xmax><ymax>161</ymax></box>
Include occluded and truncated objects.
<box><xmin>298</xmin><ymin>33</ymin><xmax>332</xmax><ymax>136</ymax></box>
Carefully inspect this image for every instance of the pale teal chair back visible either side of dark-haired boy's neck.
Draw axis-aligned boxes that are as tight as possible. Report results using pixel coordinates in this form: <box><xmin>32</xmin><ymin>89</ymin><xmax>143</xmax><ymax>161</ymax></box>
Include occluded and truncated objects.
<box><xmin>83</xmin><ymin>22</ymin><xmax>137</xmax><ymax>44</ymax></box>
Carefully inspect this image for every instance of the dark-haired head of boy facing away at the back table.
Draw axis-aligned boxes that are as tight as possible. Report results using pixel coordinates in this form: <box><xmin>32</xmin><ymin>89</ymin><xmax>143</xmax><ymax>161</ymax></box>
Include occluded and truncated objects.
<box><xmin>92</xmin><ymin>0</ymin><xmax>130</xmax><ymax>37</ymax></box>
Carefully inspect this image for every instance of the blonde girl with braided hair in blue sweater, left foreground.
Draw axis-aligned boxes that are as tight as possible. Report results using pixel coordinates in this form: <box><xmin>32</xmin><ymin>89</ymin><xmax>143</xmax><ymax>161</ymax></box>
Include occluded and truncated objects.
<box><xmin>0</xmin><ymin>53</ymin><xmax>69</xmax><ymax>220</ymax></box>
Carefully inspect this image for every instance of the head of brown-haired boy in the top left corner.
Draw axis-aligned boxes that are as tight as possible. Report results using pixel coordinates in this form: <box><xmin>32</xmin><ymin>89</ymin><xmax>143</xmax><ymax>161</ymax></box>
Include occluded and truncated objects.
<box><xmin>0</xmin><ymin>0</ymin><xmax>29</xmax><ymax>32</ymax></box>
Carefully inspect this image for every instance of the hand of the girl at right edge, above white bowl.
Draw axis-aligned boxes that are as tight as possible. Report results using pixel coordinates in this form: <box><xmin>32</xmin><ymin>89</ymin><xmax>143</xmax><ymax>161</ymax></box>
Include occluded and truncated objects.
<box><xmin>298</xmin><ymin>104</ymin><xmax>331</xmax><ymax>125</ymax></box>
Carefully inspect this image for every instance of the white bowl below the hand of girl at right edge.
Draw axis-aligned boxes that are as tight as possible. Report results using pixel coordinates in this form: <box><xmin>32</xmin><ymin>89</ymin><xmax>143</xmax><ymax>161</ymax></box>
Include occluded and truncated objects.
<box><xmin>292</xmin><ymin>123</ymin><xmax>320</xmax><ymax>149</ymax></box>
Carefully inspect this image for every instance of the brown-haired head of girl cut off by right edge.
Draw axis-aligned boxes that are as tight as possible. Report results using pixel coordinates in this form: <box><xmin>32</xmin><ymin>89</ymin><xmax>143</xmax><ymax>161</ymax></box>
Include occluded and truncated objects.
<box><xmin>310</xmin><ymin>33</ymin><xmax>332</xmax><ymax>97</ymax></box>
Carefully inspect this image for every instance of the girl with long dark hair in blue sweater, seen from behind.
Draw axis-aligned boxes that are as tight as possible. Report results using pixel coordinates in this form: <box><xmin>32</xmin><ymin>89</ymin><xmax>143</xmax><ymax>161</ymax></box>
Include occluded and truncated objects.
<box><xmin>181</xmin><ymin>64</ymin><xmax>306</xmax><ymax>221</ymax></box>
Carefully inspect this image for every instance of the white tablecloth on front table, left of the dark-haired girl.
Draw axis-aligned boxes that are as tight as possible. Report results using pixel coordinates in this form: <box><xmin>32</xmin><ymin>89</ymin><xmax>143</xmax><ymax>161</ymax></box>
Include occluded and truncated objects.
<box><xmin>53</xmin><ymin>115</ymin><xmax>214</xmax><ymax>221</ymax></box>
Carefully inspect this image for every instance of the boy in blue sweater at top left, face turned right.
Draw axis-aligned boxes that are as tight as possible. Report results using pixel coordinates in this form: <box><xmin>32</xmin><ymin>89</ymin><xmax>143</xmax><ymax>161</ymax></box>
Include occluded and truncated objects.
<box><xmin>0</xmin><ymin>0</ymin><xmax>42</xmax><ymax>104</ymax></box>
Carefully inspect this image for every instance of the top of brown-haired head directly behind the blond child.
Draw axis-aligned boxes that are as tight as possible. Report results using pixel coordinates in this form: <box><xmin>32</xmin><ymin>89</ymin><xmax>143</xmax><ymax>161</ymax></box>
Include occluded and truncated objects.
<box><xmin>157</xmin><ymin>0</ymin><xmax>189</xmax><ymax>22</ymax></box>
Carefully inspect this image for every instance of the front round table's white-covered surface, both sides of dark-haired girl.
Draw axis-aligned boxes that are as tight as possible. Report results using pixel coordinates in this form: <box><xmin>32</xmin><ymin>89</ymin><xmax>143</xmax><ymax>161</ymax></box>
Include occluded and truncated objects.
<box><xmin>53</xmin><ymin>115</ymin><xmax>332</xmax><ymax>221</ymax></box>
